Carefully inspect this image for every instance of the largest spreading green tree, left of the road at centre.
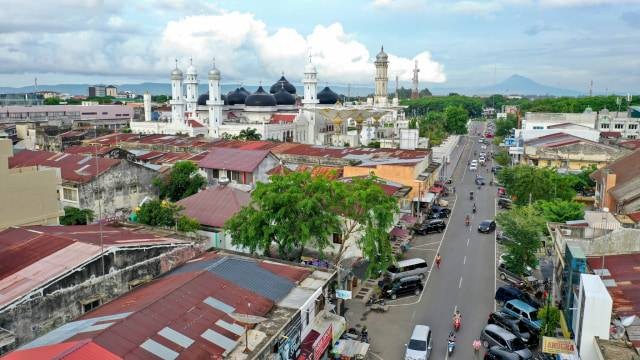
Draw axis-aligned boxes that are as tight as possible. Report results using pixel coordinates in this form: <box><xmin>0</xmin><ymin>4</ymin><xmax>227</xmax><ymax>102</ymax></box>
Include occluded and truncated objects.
<box><xmin>225</xmin><ymin>172</ymin><xmax>397</xmax><ymax>271</ymax></box>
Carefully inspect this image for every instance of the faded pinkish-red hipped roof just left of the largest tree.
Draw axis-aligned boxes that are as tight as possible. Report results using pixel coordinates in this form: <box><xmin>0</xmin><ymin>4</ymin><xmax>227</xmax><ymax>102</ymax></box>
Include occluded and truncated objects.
<box><xmin>178</xmin><ymin>186</ymin><xmax>251</xmax><ymax>228</ymax></box>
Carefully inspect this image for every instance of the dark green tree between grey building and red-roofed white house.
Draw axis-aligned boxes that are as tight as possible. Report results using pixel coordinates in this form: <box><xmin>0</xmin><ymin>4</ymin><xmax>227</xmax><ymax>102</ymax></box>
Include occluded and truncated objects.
<box><xmin>153</xmin><ymin>160</ymin><xmax>207</xmax><ymax>201</ymax></box>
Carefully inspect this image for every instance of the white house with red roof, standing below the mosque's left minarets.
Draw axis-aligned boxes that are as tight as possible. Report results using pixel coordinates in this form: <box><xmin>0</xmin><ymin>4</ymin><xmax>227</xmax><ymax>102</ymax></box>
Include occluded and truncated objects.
<box><xmin>198</xmin><ymin>148</ymin><xmax>279</xmax><ymax>188</ymax></box>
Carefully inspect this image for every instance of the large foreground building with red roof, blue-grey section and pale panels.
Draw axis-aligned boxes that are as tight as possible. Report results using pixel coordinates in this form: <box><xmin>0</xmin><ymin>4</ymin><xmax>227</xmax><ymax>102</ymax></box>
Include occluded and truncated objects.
<box><xmin>15</xmin><ymin>252</ymin><xmax>345</xmax><ymax>359</ymax></box>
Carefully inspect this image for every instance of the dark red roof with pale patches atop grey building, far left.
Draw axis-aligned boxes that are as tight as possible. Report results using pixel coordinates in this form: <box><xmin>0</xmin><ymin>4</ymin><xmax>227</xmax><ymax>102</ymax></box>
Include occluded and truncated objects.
<box><xmin>9</xmin><ymin>150</ymin><xmax>120</xmax><ymax>183</ymax></box>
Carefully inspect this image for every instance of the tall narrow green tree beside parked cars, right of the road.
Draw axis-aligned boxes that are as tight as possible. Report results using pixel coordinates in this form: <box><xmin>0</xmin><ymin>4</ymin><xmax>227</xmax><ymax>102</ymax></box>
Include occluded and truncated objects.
<box><xmin>496</xmin><ymin>206</ymin><xmax>545</xmax><ymax>275</ymax></box>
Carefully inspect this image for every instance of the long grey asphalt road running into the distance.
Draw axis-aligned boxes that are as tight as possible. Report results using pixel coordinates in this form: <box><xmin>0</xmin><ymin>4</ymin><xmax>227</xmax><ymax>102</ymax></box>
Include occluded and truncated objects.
<box><xmin>363</xmin><ymin>122</ymin><xmax>496</xmax><ymax>360</ymax></box>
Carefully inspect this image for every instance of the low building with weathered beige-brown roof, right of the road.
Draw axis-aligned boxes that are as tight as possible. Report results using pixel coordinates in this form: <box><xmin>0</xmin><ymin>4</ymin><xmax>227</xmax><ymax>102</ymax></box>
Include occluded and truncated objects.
<box><xmin>522</xmin><ymin>132</ymin><xmax>627</xmax><ymax>171</ymax></box>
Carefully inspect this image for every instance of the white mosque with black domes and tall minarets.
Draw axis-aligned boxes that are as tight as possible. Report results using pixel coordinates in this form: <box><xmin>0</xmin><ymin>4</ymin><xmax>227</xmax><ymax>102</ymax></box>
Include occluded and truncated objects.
<box><xmin>131</xmin><ymin>48</ymin><xmax>408</xmax><ymax>146</ymax></box>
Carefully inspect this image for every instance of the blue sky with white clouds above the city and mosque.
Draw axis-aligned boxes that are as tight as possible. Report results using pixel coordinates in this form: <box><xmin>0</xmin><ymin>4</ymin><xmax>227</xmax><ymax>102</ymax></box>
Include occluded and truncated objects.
<box><xmin>0</xmin><ymin>0</ymin><xmax>640</xmax><ymax>93</ymax></box>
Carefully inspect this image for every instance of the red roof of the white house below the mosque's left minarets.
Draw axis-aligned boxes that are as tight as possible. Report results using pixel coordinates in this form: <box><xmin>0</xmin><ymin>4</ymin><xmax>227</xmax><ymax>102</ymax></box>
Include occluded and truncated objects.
<box><xmin>200</xmin><ymin>148</ymin><xmax>270</xmax><ymax>172</ymax></box>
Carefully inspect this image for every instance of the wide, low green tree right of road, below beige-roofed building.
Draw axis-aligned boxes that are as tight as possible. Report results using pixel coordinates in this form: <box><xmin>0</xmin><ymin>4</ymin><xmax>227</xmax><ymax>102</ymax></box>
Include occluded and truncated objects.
<box><xmin>498</xmin><ymin>165</ymin><xmax>576</xmax><ymax>205</ymax></box>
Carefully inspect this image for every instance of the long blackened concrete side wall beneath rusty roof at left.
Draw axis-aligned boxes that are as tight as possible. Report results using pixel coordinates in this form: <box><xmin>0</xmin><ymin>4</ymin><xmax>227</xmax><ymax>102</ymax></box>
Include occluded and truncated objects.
<box><xmin>0</xmin><ymin>246</ymin><xmax>201</xmax><ymax>352</ymax></box>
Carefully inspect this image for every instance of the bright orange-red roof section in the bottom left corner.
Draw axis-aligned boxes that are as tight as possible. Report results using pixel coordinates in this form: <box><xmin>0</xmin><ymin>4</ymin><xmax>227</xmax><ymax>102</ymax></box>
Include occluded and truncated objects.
<box><xmin>2</xmin><ymin>340</ymin><xmax>122</xmax><ymax>360</ymax></box>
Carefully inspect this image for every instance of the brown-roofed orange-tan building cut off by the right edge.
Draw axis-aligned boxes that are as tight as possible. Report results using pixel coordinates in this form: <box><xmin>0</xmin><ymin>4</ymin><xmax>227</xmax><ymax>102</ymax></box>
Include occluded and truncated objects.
<box><xmin>591</xmin><ymin>150</ymin><xmax>640</xmax><ymax>214</ymax></box>
